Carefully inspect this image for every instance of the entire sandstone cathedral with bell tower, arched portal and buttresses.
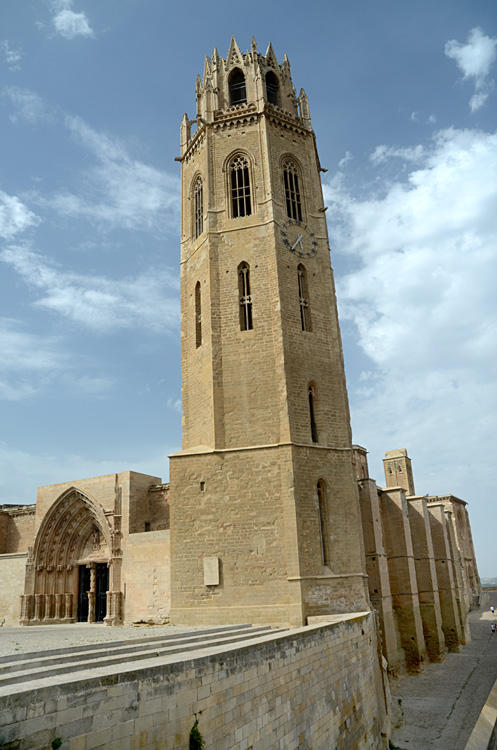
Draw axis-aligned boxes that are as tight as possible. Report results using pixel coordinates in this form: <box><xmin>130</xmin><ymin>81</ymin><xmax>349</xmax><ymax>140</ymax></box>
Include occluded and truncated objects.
<box><xmin>0</xmin><ymin>39</ymin><xmax>480</xmax><ymax>672</ymax></box>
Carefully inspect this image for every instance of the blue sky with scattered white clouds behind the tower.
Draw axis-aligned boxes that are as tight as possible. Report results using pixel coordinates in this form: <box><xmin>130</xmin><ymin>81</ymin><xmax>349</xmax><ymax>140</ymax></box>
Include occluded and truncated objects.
<box><xmin>0</xmin><ymin>0</ymin><xmax>497</xmax><ymax>577</ymax></box>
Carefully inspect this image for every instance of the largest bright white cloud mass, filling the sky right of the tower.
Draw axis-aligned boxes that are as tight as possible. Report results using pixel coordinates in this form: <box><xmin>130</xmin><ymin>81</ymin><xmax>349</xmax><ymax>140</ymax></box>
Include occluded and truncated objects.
<box><xmin>325</xmin><ymin>129</ymin><xmax>497</xmax><ymax>512</ymax></box>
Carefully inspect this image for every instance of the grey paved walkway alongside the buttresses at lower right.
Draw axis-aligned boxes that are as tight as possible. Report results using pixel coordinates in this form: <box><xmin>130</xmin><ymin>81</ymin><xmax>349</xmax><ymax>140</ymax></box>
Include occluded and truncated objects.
<box><xmin>392</xmin><ymin>591</ymin><xmax>497</xmax><ymax>750</ymax></box>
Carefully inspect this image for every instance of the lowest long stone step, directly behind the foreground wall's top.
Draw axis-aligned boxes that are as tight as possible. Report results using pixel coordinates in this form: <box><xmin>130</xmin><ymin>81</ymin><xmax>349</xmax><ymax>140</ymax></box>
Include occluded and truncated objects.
<box><xmin>0</xmin><ymin>627</ymin><xmax>284</xmax><ymax>688</ymax></box>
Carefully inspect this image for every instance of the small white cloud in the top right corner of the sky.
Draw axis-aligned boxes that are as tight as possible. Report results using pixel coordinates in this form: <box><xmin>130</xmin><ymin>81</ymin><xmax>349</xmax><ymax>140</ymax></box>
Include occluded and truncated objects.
<box><xmin>445</xmin><ymin>27</ymin><xmax>497</xmax><ymax>112</ymax></box>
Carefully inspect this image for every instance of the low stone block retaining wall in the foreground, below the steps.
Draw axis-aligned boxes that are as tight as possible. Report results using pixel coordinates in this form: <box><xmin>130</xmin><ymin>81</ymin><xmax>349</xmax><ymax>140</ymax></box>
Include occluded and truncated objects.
<box><xmin>0</xmin><ymin>614</ymin><xmax>385</xmax><ymax>750</ymax></box>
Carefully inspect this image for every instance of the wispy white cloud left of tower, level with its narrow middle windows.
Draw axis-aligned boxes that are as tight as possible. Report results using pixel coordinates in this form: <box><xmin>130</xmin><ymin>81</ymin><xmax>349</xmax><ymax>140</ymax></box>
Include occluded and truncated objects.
<box><xmin>0</xmin><ymin>245</ymin><xmax>179</xmax><ymax>333</ymax></box>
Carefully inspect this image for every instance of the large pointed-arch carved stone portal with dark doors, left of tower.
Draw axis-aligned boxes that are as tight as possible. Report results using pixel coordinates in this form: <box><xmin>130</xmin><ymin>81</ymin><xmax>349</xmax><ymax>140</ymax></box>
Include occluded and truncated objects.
<box><xmin>21</xmin><ymin>487</ymin><xmax>121</xmax><ymax>624</ymax></box>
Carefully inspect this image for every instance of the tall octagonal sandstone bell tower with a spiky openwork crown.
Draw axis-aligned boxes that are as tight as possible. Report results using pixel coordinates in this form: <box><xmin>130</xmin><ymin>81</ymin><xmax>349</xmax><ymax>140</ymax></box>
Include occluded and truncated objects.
<box><xmin>170</xmin><ymin>39</ymin><xmax>368</xmax><ymax>626</ymax></box>
